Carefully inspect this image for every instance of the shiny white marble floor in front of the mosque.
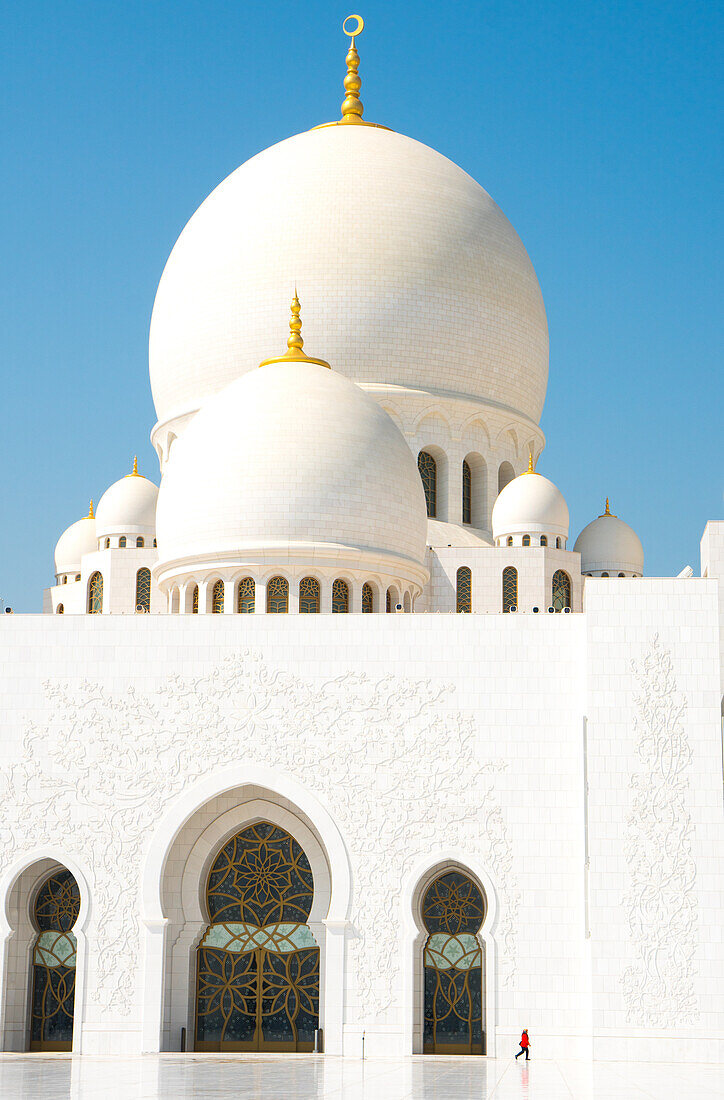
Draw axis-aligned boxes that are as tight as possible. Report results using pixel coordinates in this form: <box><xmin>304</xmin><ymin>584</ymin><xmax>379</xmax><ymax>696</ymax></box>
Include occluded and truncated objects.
<box><xmin>0</xmin><ymin>1054</ymin><xmax>724</xmax><ymax>1100</ymax></box>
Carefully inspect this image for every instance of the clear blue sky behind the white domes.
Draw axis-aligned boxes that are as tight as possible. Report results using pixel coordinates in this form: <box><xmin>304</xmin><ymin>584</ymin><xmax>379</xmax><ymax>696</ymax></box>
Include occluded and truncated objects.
<box><xmin>0</xmin><ymin>0</ymin><xmax>724</xmax><ymax>611</ymax></box>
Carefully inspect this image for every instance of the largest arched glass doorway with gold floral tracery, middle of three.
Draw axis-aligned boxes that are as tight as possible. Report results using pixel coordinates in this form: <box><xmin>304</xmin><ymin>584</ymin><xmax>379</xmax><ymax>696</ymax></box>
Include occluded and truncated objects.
<box><xmin>195</xmin><ymin>822</ymin><xmax>319</xmax><ymax>1052</ymax></box>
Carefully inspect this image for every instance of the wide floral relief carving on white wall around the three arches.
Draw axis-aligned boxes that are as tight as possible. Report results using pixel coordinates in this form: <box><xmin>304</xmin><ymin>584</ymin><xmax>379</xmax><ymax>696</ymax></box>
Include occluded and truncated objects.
<box><xmin>0</xmin><ymin>652</ymin><xmax>519</xmax><ymax>1018</ymax></box>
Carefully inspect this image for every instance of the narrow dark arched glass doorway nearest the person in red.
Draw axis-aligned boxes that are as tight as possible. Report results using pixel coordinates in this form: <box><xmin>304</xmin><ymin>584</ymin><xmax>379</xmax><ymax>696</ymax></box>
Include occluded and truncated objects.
<box><xmin>421</xmin><ymin>870</ymin><xmax>485</xmax><ymax>1054</ymax></box>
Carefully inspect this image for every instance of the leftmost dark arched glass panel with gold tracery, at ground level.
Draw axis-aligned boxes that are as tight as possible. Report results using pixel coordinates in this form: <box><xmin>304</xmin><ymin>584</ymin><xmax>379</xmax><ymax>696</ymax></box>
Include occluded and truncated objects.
<box><xmin>30</xmin><ymin>868</ymin><xmax>80</xmax><ymax>1051</ymax></box>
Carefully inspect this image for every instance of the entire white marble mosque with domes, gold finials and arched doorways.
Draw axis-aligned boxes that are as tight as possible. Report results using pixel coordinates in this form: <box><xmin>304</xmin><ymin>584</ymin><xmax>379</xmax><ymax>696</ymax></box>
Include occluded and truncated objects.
<box><xmin>0</xmin><ymin>17</ymin><xmax>724</xmax><ymax>1062</ymax></box>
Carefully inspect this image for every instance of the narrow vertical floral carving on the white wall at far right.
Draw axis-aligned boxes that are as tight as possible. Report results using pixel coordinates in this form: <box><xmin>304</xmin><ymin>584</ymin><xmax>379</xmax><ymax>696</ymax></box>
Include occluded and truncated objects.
<box><xmin>622</xmin><ymin>635</ymin><xmax>699</xmax><ymax>1027</ymax></box>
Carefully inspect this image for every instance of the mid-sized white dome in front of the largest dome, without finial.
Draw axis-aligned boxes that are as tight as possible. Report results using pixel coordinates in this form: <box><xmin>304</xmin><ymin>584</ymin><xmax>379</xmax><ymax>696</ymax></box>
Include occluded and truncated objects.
<box><xmin>156</xmin><ymin>361</ymin><xmax>427</xmax><ymax>586</ymax></box>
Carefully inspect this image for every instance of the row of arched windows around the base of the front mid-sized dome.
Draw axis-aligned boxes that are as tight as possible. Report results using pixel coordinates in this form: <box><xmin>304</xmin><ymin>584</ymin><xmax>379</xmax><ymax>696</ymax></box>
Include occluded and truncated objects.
<box><xmin>169</xmin><ymin>575</ymin><xmax>412</xmax><ymax>615</ymax></box>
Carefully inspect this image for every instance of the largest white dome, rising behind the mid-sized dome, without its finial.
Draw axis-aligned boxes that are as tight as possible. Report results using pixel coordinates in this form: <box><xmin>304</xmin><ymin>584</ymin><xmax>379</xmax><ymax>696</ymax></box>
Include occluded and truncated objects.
<box><xmin>150</xmin><ymin>125</ymin><xmax>548</xmax><ymax>433</ymax></box>
